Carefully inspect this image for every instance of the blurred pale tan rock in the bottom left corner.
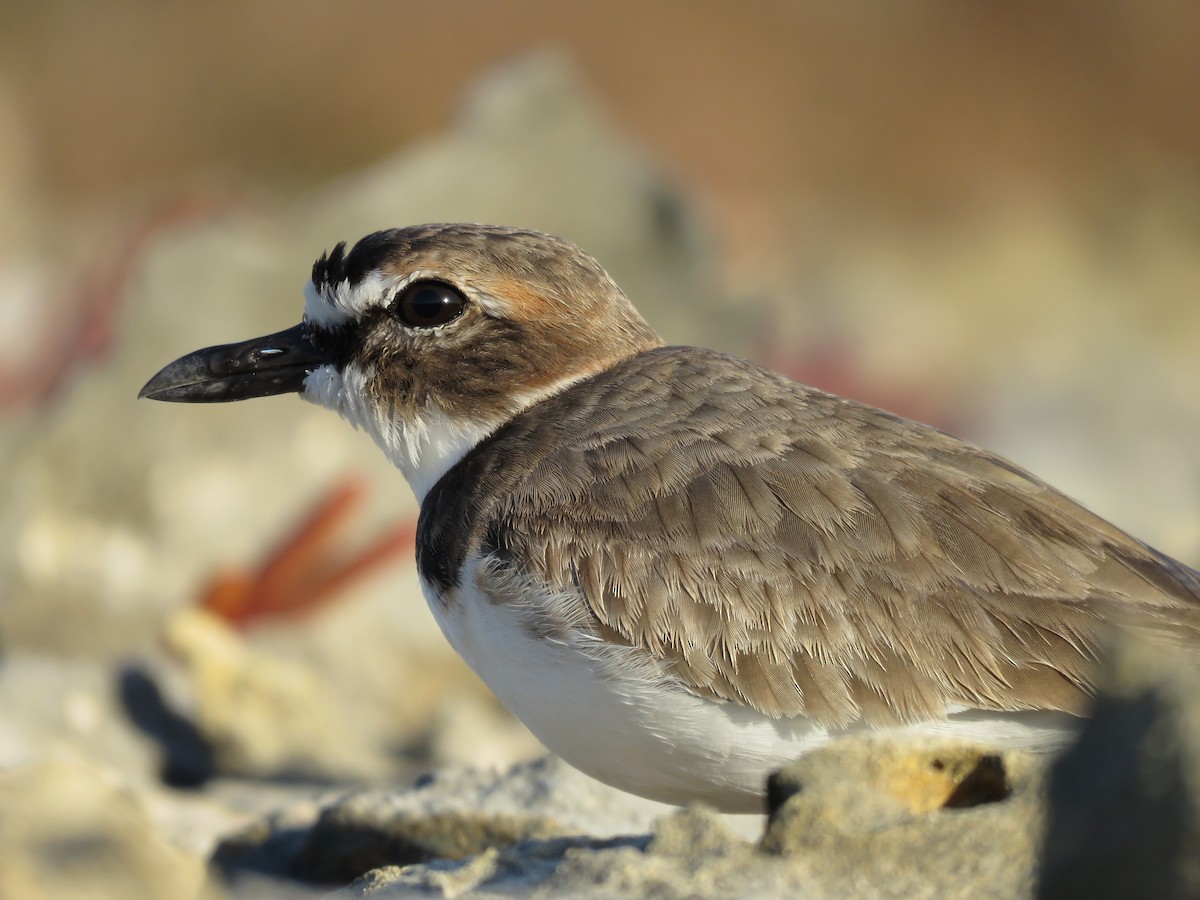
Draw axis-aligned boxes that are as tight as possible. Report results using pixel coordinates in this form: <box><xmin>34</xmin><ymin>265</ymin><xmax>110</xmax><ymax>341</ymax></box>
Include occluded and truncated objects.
<box><xmin>0</xmin><ymin>762</ymin><xmax>217</xmax><ymax>900</ymax></box>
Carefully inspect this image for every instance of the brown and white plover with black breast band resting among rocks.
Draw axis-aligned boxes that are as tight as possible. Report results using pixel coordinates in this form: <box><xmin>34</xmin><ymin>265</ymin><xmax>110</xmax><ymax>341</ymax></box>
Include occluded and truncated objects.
<box><xmin>139</xmin><ymin>223</ymin><xmax>1200</xmax><ymax>812</ymax></box>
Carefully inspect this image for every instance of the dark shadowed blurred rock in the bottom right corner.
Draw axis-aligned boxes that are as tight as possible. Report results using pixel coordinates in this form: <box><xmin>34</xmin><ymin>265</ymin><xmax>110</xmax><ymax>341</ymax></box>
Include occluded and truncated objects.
<box><xmin>1038</xmin><ymin>637</ymin><xmax>1200</xmax><ymax>900</ymax></box>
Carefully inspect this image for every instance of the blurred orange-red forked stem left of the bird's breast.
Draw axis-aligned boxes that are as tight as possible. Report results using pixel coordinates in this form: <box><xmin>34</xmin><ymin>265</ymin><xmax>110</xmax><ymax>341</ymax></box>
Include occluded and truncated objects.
<box><xmin>199</xmin><ymin>476</ymin><xmax>416</xmax><ymax>628</ymax></box>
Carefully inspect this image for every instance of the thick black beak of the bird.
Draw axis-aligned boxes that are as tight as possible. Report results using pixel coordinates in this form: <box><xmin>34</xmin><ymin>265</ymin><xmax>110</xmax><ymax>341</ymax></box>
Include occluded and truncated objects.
<box><xmin>138</xmin><ymin>324</ymin><xmax>332</xmax><ymax>403</ymax></box>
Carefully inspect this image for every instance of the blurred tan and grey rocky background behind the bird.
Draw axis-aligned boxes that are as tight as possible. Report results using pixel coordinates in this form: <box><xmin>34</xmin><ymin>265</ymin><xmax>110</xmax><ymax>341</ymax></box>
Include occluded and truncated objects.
<box><xmin>0</xmin><ymin>0</ymin><xmax>1200</xmax><ymax>895</ymax></box>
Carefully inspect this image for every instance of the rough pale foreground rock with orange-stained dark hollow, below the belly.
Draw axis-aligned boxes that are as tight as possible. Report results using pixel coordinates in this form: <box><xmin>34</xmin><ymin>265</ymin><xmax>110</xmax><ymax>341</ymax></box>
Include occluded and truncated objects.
<box><xmin>316</xmin><ymin>738</ymin><xmax>1043</xmax><ymax>898</ymax></box>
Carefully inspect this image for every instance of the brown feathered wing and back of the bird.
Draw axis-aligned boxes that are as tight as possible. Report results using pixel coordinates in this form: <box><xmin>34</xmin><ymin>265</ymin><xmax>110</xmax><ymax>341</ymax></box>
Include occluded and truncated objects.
<box><xmin>482</xmin><ymin>348</ymin><xmax>1200</xmax><ymax>726</ymax></box>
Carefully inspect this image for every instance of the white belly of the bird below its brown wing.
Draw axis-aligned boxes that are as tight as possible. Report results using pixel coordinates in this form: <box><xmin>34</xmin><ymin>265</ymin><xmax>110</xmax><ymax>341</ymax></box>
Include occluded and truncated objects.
<box><xmin>422</xmin><ymin>563</ymin><xmax>1069</xmax><ymax>812</ymax></box>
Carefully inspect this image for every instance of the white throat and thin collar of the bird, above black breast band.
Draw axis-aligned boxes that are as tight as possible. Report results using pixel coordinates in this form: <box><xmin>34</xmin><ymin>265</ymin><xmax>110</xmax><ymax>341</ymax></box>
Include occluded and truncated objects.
<box><xmin>301</xmin><ymin>364</ymin><xmax>595</xmax><ymax>503</ymax></box>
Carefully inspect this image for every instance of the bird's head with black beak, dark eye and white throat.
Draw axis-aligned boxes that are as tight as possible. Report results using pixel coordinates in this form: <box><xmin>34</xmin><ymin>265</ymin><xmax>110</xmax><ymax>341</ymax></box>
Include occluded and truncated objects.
<box><xmin>139</xmin><ymin>224</ymin><xmax>662</xmax><ymax>498</ymax></box>
